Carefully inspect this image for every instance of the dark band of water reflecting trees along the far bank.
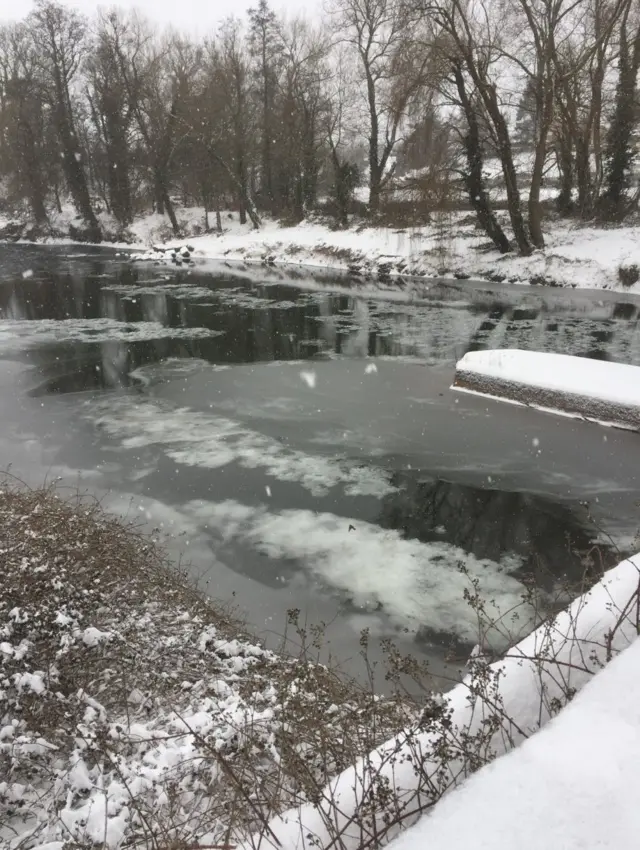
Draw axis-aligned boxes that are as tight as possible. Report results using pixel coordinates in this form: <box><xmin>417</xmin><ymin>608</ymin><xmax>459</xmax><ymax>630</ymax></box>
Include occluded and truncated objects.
<box><xmin>0</xmin><ymin>243</ymin><xmax>640</xmax><ymax>392</ymax></box>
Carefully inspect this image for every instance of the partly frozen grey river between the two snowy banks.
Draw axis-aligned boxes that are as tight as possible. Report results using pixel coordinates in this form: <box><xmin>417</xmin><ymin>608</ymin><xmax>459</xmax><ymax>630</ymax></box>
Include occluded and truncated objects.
<box><xmin>0</xmin><ymin>240</ymin><xmax>640</xmax><ymax>678</ymax></box>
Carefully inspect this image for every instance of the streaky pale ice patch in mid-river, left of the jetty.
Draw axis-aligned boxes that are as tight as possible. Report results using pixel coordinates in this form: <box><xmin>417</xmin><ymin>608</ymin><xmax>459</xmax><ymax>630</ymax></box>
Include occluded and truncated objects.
<box><xmin>84</xmin><ymin>395</ymin><xmax>396</xmax><ymax>497</ymax></box>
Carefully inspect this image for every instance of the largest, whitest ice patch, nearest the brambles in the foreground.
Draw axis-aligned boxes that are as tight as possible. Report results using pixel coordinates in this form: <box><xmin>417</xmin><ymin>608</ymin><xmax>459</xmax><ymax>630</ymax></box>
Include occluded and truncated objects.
<box><xmin>186</xmin><ymin>501</ymin><xmax>534</xmax><ymax>649</ymax></box>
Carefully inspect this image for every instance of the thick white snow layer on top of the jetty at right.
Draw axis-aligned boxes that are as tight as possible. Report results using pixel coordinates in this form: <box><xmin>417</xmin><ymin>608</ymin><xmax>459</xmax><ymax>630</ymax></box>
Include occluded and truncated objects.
<box><xmin>456</xmin><ymin>349</ymin><xmax>640</xmax><ymax>407</ymax></box>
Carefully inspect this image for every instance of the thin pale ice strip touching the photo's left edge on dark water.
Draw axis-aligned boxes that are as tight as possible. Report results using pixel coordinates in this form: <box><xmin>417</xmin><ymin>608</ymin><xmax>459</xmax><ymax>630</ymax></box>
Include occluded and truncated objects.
<box><xmin>0</xmin><ymin>318</ymin><xmax>222</xmax><ymax>352</ymax></box>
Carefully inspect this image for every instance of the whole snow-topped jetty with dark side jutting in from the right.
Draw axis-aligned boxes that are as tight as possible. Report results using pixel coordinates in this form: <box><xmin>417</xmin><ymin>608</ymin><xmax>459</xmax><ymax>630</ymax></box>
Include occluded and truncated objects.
<box><xmin>452</xmin><ymin>349</ymin><xmax>640</xmax><ymax>429</ymax></box>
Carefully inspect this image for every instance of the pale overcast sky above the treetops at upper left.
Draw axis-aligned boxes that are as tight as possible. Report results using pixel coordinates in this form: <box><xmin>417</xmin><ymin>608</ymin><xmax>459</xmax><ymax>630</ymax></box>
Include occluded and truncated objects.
<box><xmin>0</xmin><ymin>0</ymin><xmax>321</xmax><ymax>35</ymax></box>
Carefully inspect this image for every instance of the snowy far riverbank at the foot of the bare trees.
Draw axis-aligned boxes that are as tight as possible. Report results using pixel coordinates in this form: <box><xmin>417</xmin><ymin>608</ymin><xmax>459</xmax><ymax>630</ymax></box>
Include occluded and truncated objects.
<box><xmin>126</xmin><ymin>209</ymin><xmax>640</xmax><ymax>291</ymax></box>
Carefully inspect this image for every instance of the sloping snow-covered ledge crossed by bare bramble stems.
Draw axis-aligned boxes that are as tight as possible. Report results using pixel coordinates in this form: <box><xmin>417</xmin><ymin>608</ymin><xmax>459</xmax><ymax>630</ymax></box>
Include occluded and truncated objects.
<box><xmin>247</xmin><ymin>555</ymin><xmax>640</xmax><ymax>850</ymax></box>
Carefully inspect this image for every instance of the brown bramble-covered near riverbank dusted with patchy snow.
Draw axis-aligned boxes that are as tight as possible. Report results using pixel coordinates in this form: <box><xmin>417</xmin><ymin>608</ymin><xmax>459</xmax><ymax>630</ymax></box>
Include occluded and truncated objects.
<box><xmin>0</xmin><ymin>480</ymin><xmax>412</xmax><ymax>850</ymax></box>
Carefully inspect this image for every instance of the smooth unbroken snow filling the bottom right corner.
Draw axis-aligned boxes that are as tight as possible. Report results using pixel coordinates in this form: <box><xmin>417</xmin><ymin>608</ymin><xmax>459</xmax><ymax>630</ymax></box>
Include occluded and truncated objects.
<box><xmin>391</xmin><ymin>640</ymin><xmax>640</xmax><ymax>850</ymax></box>
